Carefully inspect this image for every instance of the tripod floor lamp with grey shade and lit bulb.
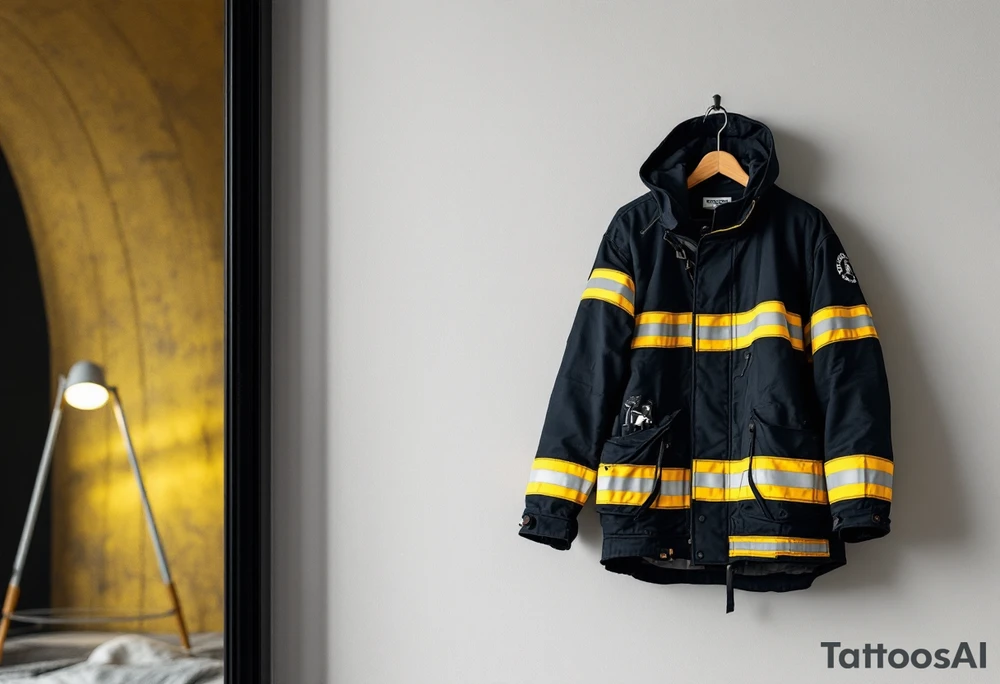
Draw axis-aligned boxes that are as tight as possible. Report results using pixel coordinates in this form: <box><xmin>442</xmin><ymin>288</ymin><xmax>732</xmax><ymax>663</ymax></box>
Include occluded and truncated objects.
<box><xmin>0</xmin><ymin>361</ymin><xmax>191</xmax><ymax>659</ymax></box>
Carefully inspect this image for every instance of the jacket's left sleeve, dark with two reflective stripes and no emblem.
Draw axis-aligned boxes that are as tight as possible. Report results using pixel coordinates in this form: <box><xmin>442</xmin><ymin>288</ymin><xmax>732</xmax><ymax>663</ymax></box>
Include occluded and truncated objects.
<box><xmin>520</xmin><ymin>224</ymin><xmax>635</xmax><ymax>549</ymax></box>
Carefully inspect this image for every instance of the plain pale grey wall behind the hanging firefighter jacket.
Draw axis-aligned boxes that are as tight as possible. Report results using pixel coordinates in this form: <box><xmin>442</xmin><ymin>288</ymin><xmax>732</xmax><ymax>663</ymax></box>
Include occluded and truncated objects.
<box><xmin>274</xmin><ymin>0</ymin><xmax>1000</xmax><ymax>684</ymax></box>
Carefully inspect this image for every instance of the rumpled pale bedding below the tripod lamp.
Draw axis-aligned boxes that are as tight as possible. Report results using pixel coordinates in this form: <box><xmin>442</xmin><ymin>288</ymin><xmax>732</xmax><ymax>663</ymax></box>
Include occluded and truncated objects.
<box><xmin>0</xmin><ymin>634</ymin><xmax>223</xmax><ymax>684</ymax></box>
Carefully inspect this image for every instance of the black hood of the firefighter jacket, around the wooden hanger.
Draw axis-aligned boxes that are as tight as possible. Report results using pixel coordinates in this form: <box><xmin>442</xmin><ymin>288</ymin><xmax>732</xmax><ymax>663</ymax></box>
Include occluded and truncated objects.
<box><xmin>639</xmin><ymin>112</ymin><xmax>778</xmax><ymax>230</ymax></box>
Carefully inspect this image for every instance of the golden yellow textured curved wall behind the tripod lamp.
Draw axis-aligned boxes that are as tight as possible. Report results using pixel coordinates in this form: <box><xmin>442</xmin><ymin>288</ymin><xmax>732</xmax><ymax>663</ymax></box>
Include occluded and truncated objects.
<box><xmin>0</xmin><ymin>0</ymin><xmax>224</xmax><ymax>631</ymax></box>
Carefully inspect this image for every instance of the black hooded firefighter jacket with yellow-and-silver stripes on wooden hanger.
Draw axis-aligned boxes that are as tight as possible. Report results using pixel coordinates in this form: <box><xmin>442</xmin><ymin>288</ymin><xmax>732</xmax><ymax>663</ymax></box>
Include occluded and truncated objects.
<box><xmin>520</xmin><ymin>114</ymin><xmax>893</xmax><ymax>610</ymax></box>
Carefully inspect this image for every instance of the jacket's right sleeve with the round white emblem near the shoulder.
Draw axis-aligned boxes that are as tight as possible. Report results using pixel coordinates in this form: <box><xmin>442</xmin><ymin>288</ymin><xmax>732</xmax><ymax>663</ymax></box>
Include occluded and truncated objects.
<box><xmin>807</xmin><ymin>220</ymin><xmax>893</xmax><ymax>542</ymax></box>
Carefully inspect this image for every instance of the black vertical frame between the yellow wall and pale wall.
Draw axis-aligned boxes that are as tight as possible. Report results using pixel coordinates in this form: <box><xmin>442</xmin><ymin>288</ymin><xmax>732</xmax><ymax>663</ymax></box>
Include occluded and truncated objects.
<box><xmin>224</xmin><ymin>0</ymin><xmax>271</xmax><ymax>684</ymax></box>
